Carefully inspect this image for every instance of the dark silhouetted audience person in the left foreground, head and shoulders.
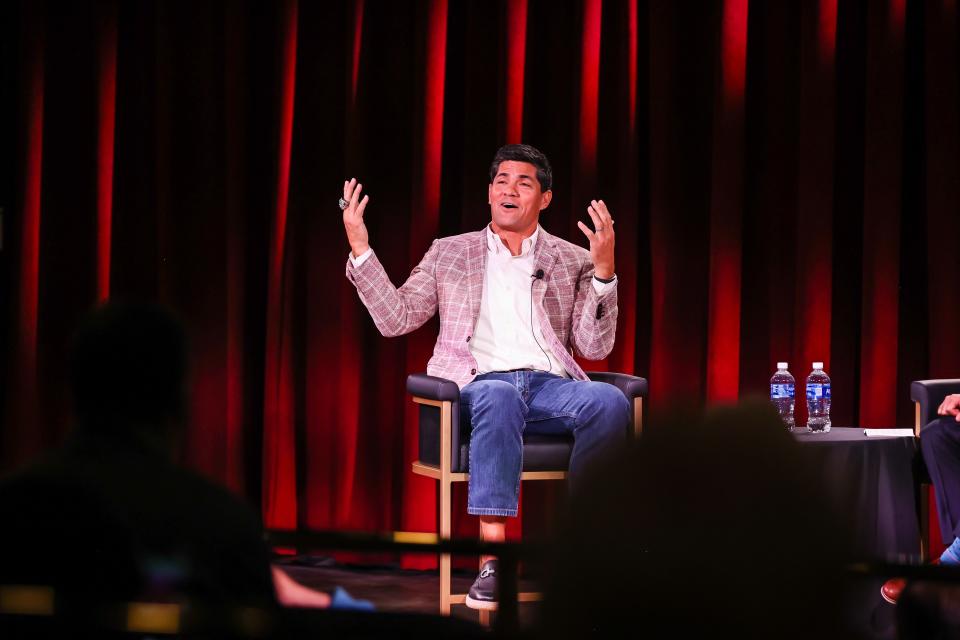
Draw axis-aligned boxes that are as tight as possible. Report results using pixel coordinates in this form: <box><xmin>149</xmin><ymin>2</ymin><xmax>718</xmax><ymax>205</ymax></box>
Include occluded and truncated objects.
<box><xmin>0</xmin><ymin>303</ymin><xmax>330</xmax><ymax>609</ymax></box>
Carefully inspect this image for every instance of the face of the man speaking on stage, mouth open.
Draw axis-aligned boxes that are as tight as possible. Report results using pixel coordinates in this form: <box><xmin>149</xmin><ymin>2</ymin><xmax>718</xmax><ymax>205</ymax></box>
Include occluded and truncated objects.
<box><xmin>487</xmin><ymin>160</ymin><xmax>553</xmax><ymax>236</ymax></box>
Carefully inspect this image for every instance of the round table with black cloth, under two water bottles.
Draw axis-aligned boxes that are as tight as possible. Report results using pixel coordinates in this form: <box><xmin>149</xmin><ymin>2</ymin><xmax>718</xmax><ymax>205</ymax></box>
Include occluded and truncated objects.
<box><xmin>795</xmin><ymin>427</ymin><xmax>920</xmax><ymax>563</ymax></box>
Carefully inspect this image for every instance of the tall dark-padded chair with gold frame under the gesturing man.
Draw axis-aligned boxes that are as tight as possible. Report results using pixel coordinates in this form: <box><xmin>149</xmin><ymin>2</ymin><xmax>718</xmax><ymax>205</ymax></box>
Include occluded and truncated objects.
<box><xmin>407</xmin><ymin>372</ymin><xmax>647</xmax><ymax>620</ymax></box>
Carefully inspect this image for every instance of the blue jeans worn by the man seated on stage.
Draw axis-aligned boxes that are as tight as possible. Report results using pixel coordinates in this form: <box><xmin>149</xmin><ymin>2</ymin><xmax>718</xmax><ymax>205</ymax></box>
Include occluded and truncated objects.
<box><xmin>460</xmin><ymin>371</ymin><xmax>630</xmax><ymax>516</ymax></box>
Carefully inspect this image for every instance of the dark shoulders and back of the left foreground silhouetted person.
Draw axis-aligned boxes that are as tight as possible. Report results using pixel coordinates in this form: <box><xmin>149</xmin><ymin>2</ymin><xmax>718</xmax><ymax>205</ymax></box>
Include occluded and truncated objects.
<box><xmin>0</xmin><ymin>436</ymin><xmax>274</xmax><ymax>603</ymax></box>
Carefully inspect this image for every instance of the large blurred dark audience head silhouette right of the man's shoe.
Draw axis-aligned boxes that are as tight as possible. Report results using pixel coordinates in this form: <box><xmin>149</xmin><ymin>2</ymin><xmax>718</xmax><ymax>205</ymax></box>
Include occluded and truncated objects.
<box><xmin>542</xmin><ymin>402</ymin><xmax>851</xmax><ymax>638</ymax></box>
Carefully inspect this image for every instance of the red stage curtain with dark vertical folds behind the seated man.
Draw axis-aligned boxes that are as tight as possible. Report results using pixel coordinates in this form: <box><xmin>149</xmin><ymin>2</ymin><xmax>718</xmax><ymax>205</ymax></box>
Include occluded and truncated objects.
<box><xmin>0</xmin><ymin>0</ymin><xmax>960</xmax><ymax>566</ymax></box>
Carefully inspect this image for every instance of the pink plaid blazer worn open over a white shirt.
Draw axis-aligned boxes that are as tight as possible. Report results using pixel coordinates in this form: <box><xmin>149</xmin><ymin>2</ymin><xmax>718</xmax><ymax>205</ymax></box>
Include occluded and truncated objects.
<box><xmin>347</xmin><ymin>228</ymin><xmax>617</xmax><ymax>388</ymax></box>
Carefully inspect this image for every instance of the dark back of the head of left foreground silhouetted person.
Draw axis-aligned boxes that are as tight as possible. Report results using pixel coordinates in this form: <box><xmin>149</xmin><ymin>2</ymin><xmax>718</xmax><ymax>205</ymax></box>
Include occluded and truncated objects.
<box><xmin>70</xmin><ymin>302</ymin><xmax>188</xmax><ymax>431</ymax></box>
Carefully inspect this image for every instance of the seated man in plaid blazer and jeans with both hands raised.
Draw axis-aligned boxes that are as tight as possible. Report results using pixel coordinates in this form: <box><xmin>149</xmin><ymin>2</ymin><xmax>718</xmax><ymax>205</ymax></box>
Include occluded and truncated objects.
<box><xmin>340</xmin><ymin>145</ymin><xmax>630</xmax><ymax>609</ymax></box>
